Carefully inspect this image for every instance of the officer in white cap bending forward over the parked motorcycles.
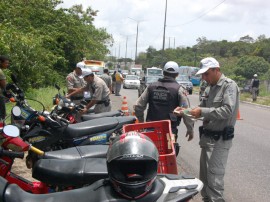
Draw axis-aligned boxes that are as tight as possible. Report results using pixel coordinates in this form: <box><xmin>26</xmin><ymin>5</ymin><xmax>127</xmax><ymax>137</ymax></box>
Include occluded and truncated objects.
<box><xmin>66</xmin><ymin>68</ymin><xmax>112</xmax><ymax>114</ymax></box>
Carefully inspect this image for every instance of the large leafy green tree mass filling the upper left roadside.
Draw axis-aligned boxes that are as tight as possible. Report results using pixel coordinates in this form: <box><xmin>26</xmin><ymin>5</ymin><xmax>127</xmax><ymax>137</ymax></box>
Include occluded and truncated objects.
<box><xmin>0</xmin><ymin>0</ymin><xmax>112</xmax><ymax>89</ymax></box>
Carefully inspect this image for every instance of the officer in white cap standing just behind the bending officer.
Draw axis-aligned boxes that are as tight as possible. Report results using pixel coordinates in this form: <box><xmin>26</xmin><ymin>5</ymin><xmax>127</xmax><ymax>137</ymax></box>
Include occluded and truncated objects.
<box><xmin>66</xmin><ymin>62</ymin><xmax>86</xmax><ymax>104</ymax></box>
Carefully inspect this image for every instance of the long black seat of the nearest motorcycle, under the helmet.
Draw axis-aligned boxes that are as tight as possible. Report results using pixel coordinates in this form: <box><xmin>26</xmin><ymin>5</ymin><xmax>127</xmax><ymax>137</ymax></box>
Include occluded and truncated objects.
<box><xmin>0</xmin><ymin>179</ymin><xmax>165</xmax><ymax>202</ymax></box>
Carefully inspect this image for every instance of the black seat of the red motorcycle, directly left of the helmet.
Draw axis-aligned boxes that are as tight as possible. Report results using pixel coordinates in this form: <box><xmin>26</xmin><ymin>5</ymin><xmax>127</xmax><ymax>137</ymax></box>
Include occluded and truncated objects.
<box><xmin>32</xmin><ymin>158</ymin><xmax>108</xmax><ymax>186</ymax></box>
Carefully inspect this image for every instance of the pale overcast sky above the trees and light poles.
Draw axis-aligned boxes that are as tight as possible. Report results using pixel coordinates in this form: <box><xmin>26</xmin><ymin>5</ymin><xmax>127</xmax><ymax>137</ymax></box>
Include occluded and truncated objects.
<box><xmin>62</xmin><ymin>0</ymin><xmax>270</xmax><ymax>59</ymax></box>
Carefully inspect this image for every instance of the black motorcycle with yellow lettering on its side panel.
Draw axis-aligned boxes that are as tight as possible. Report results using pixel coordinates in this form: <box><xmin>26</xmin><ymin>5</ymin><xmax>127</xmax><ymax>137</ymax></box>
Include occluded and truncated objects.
<box><xmin>9</xmin><ymin>103</ymin><xmax>136</xmax><ymax>168</ymax></box>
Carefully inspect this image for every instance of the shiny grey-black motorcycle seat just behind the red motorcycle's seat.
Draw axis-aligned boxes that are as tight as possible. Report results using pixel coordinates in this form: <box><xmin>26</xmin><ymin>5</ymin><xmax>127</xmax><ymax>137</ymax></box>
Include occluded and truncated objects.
<box><xmin>40</xmin><ymin>145</ymin><xmax>109</xmax><ymax>159</ymax></box>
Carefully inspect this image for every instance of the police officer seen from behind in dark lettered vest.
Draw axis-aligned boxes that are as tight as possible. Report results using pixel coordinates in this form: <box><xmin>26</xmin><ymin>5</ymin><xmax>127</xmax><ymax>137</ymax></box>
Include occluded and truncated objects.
<box><xmin>134</xmin><ymin>61</ymin><xmax>194</xmax><ymax>141</ymax></box>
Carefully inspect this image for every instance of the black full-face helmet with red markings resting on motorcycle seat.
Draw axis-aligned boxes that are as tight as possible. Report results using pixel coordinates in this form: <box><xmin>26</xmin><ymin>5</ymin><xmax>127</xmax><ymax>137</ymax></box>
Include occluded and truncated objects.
<box><xmin>107</xmin><ymin>131</ymin><xmax>159</xmax><ymax>199</ymax></box>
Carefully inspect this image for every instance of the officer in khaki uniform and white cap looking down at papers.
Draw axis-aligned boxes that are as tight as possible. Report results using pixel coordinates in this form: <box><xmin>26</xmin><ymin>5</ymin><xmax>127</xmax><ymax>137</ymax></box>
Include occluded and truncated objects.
<box><xmin>190</xmin><ymin>57</ymin><xmax>239</xmax><ymax>202</ymax></box>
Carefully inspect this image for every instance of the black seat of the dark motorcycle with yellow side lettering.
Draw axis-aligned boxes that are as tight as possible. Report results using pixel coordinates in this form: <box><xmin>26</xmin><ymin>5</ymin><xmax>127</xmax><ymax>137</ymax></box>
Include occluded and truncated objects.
<box><xmin>64</xmin><ymin>117</ymin><xmax>119</xmax><ymax>138</ymax></box>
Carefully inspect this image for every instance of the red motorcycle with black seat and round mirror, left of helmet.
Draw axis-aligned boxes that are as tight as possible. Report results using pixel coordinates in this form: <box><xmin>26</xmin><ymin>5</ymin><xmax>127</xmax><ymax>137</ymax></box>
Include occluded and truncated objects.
<box><xmin>0</xmin><ymin>122</ymin><xmax>108</xmax><ymax>194</ymax></box>
